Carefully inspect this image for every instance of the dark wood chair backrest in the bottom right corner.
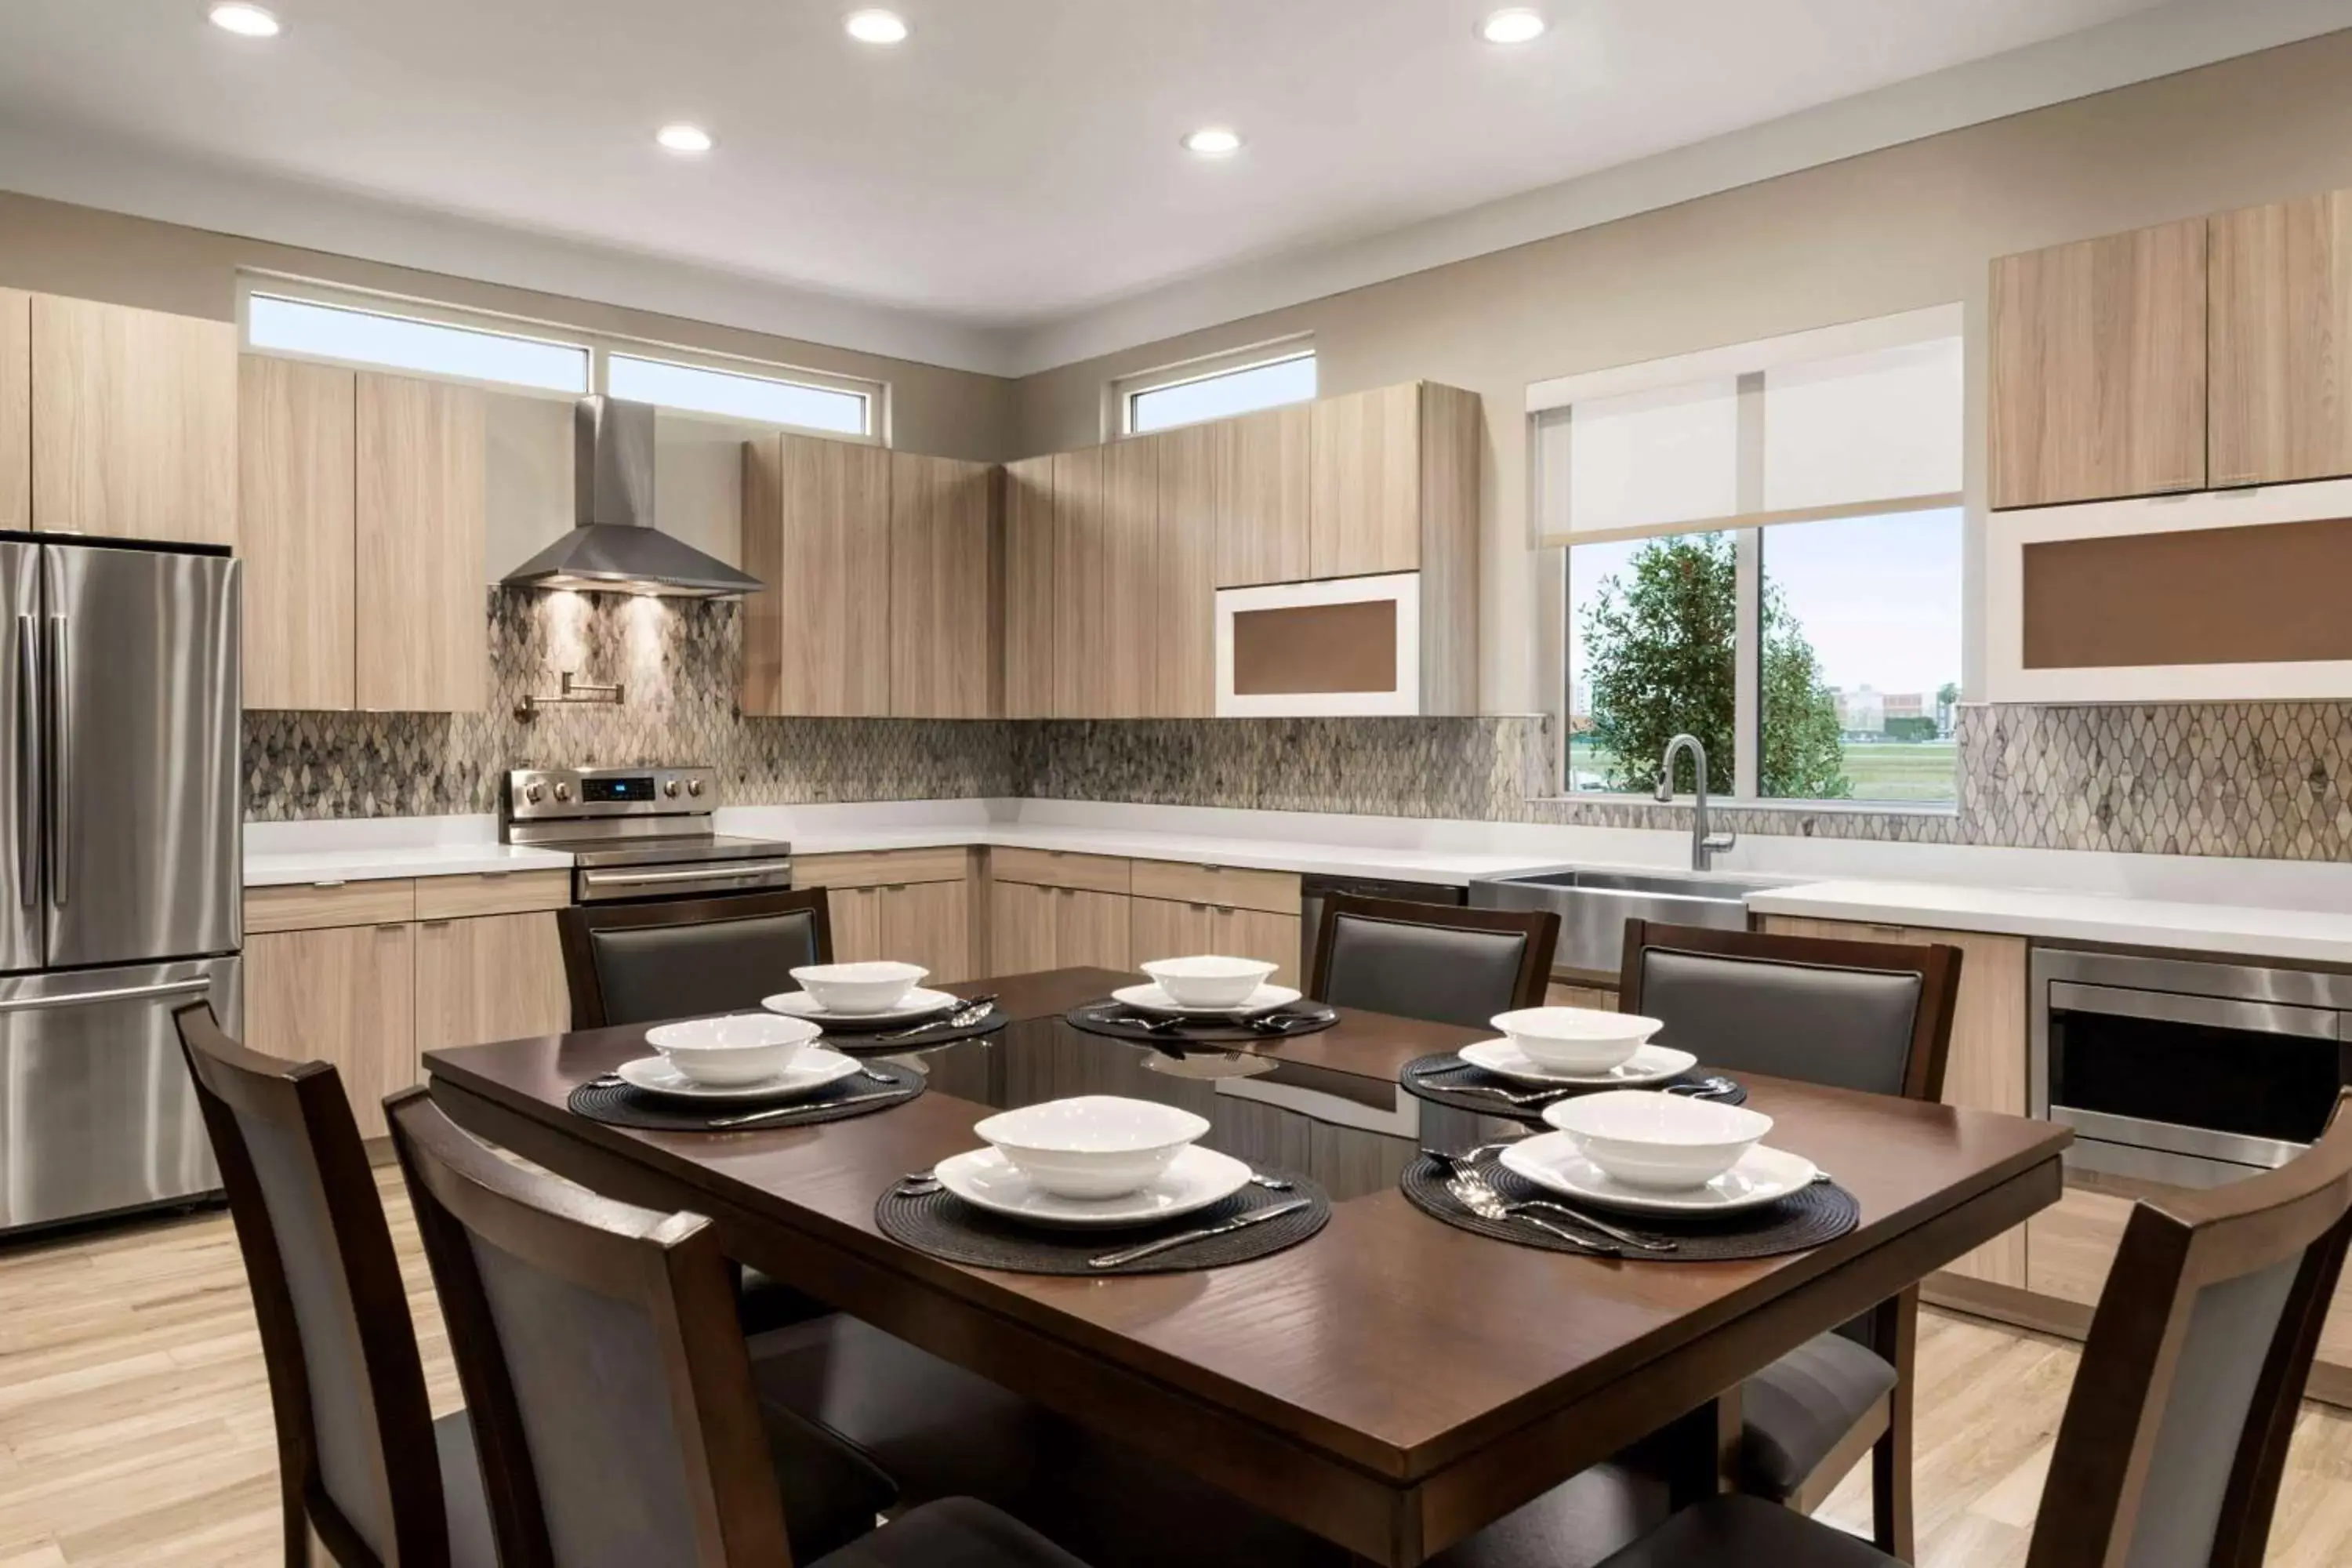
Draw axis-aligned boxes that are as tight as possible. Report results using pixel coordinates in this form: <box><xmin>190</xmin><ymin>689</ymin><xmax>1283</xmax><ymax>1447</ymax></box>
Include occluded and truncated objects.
<box><xmin>2027</xmin><ymin>1091</ymin><xmax>2352</xmax><ymax>1568</ymax></box>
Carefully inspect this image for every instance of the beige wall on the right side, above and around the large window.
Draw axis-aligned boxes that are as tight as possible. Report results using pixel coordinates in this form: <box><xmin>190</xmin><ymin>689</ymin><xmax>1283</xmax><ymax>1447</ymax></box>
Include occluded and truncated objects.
<box><xmin>1016</xmin><ymin>33</ymin><xmax>2352</xmax><ymax>713</ymax></box>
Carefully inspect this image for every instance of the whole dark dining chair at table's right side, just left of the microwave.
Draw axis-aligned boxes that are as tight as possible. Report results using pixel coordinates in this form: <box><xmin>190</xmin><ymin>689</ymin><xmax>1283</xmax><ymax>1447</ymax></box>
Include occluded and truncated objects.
<box><xmin>1618</xmin><ymin>919</ymin><xmax>1962</xmax><ymax>1561</ymax></box>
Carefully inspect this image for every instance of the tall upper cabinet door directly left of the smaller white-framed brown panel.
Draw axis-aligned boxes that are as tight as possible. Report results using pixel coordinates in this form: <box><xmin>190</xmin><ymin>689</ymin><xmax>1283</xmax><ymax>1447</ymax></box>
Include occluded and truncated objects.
<box><xmin>1150</xmin><ymin>423</ymin><xmax>1232</xmax><ymax>720</ymax></box>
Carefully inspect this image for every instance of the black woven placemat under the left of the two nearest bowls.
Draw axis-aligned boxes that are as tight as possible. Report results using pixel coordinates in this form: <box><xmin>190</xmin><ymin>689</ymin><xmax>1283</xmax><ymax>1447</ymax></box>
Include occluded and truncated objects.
<box><xmin>875</xmin><ymin>1171</ymin><xmax>1331</xmax><ymax>1279</ymax></box>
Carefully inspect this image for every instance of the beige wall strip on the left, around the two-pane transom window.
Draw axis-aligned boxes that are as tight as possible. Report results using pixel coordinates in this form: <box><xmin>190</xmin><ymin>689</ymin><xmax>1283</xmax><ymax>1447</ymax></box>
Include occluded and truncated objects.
<box><xmin>0</xmin><ymin>191</ymin><xmax>1016</xmax><ymax>461</ymax></box>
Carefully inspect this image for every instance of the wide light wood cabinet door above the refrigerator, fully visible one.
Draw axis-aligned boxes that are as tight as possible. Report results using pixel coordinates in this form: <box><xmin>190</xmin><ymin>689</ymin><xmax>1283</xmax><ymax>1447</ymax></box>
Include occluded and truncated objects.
<box><xmin>31</xmin><ymin>294</ymin><xmax>238</xmax><ymax>546</ymax></box>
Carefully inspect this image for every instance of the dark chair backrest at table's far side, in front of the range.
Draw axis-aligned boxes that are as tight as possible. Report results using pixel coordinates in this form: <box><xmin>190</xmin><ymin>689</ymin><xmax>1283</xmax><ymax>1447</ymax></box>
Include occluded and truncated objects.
<box><xmin>557</xmin><ymin>888</ymin><xmax>833</xmax><ymax>1029</ymax></box>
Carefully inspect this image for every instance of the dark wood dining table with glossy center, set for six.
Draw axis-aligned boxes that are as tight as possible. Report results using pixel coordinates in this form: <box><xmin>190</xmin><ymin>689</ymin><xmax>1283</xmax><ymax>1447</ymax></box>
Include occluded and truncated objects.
<box><xmin>426</xmin><ymin>968</ymin><xmax>2070</xmax><ymax>1568</ymax></box>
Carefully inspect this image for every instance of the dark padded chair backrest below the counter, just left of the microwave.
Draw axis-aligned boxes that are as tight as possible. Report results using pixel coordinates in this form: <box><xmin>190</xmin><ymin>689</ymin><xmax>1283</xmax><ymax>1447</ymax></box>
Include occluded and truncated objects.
<box><xmin>1618</xmin><ymin>919</ymin><xmax>1962</xmax><ymax>1100</ymax></box>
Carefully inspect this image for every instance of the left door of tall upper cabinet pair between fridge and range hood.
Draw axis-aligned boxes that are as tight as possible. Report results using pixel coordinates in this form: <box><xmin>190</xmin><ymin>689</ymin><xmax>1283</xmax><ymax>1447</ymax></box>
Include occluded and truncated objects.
<box><xmin>238</xmin><ymin>355</ymin><xmax>358</xmax><ymax>710</ymax></box>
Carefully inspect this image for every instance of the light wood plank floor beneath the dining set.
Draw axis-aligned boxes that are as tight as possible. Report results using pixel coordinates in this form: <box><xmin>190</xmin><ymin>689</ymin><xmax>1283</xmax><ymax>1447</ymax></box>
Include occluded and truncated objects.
<box><xmin>0</xmin><ymin>1185</ymin><xmax>2352</xmax><ymax>1568</ymax></box>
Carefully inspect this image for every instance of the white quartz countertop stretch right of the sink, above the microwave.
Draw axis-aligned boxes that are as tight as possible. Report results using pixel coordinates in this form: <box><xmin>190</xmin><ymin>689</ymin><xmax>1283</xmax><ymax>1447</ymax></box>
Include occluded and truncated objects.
<box><xmin>1748</xmin><ymin>881</ymin><xmax>2352</xmax><ymax>964</ymax></box>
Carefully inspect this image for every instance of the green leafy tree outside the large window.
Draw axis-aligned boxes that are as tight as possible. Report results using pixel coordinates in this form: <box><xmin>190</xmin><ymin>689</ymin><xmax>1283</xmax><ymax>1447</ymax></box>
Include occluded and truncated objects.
<box><xmin>1581</xmin><ymin>534</ymin><xmax>1853</xmax><ymax>799</ymax></box>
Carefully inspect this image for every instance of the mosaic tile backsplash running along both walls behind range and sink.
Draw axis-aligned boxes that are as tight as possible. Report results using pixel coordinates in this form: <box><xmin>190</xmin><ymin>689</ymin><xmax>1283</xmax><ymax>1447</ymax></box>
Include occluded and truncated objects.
<box><xmin>245</xmin><ymin>590</ymin><xmax>2352</xmax><ymax>860</ymax></box>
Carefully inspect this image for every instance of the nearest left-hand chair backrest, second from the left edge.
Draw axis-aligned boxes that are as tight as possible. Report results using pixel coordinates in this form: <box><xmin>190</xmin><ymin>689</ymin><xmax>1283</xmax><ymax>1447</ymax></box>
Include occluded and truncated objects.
<box><xmin>386</xmin><ymin>1088</ymin><xmax>793</xmax><ymax>1568</ymax></box>
